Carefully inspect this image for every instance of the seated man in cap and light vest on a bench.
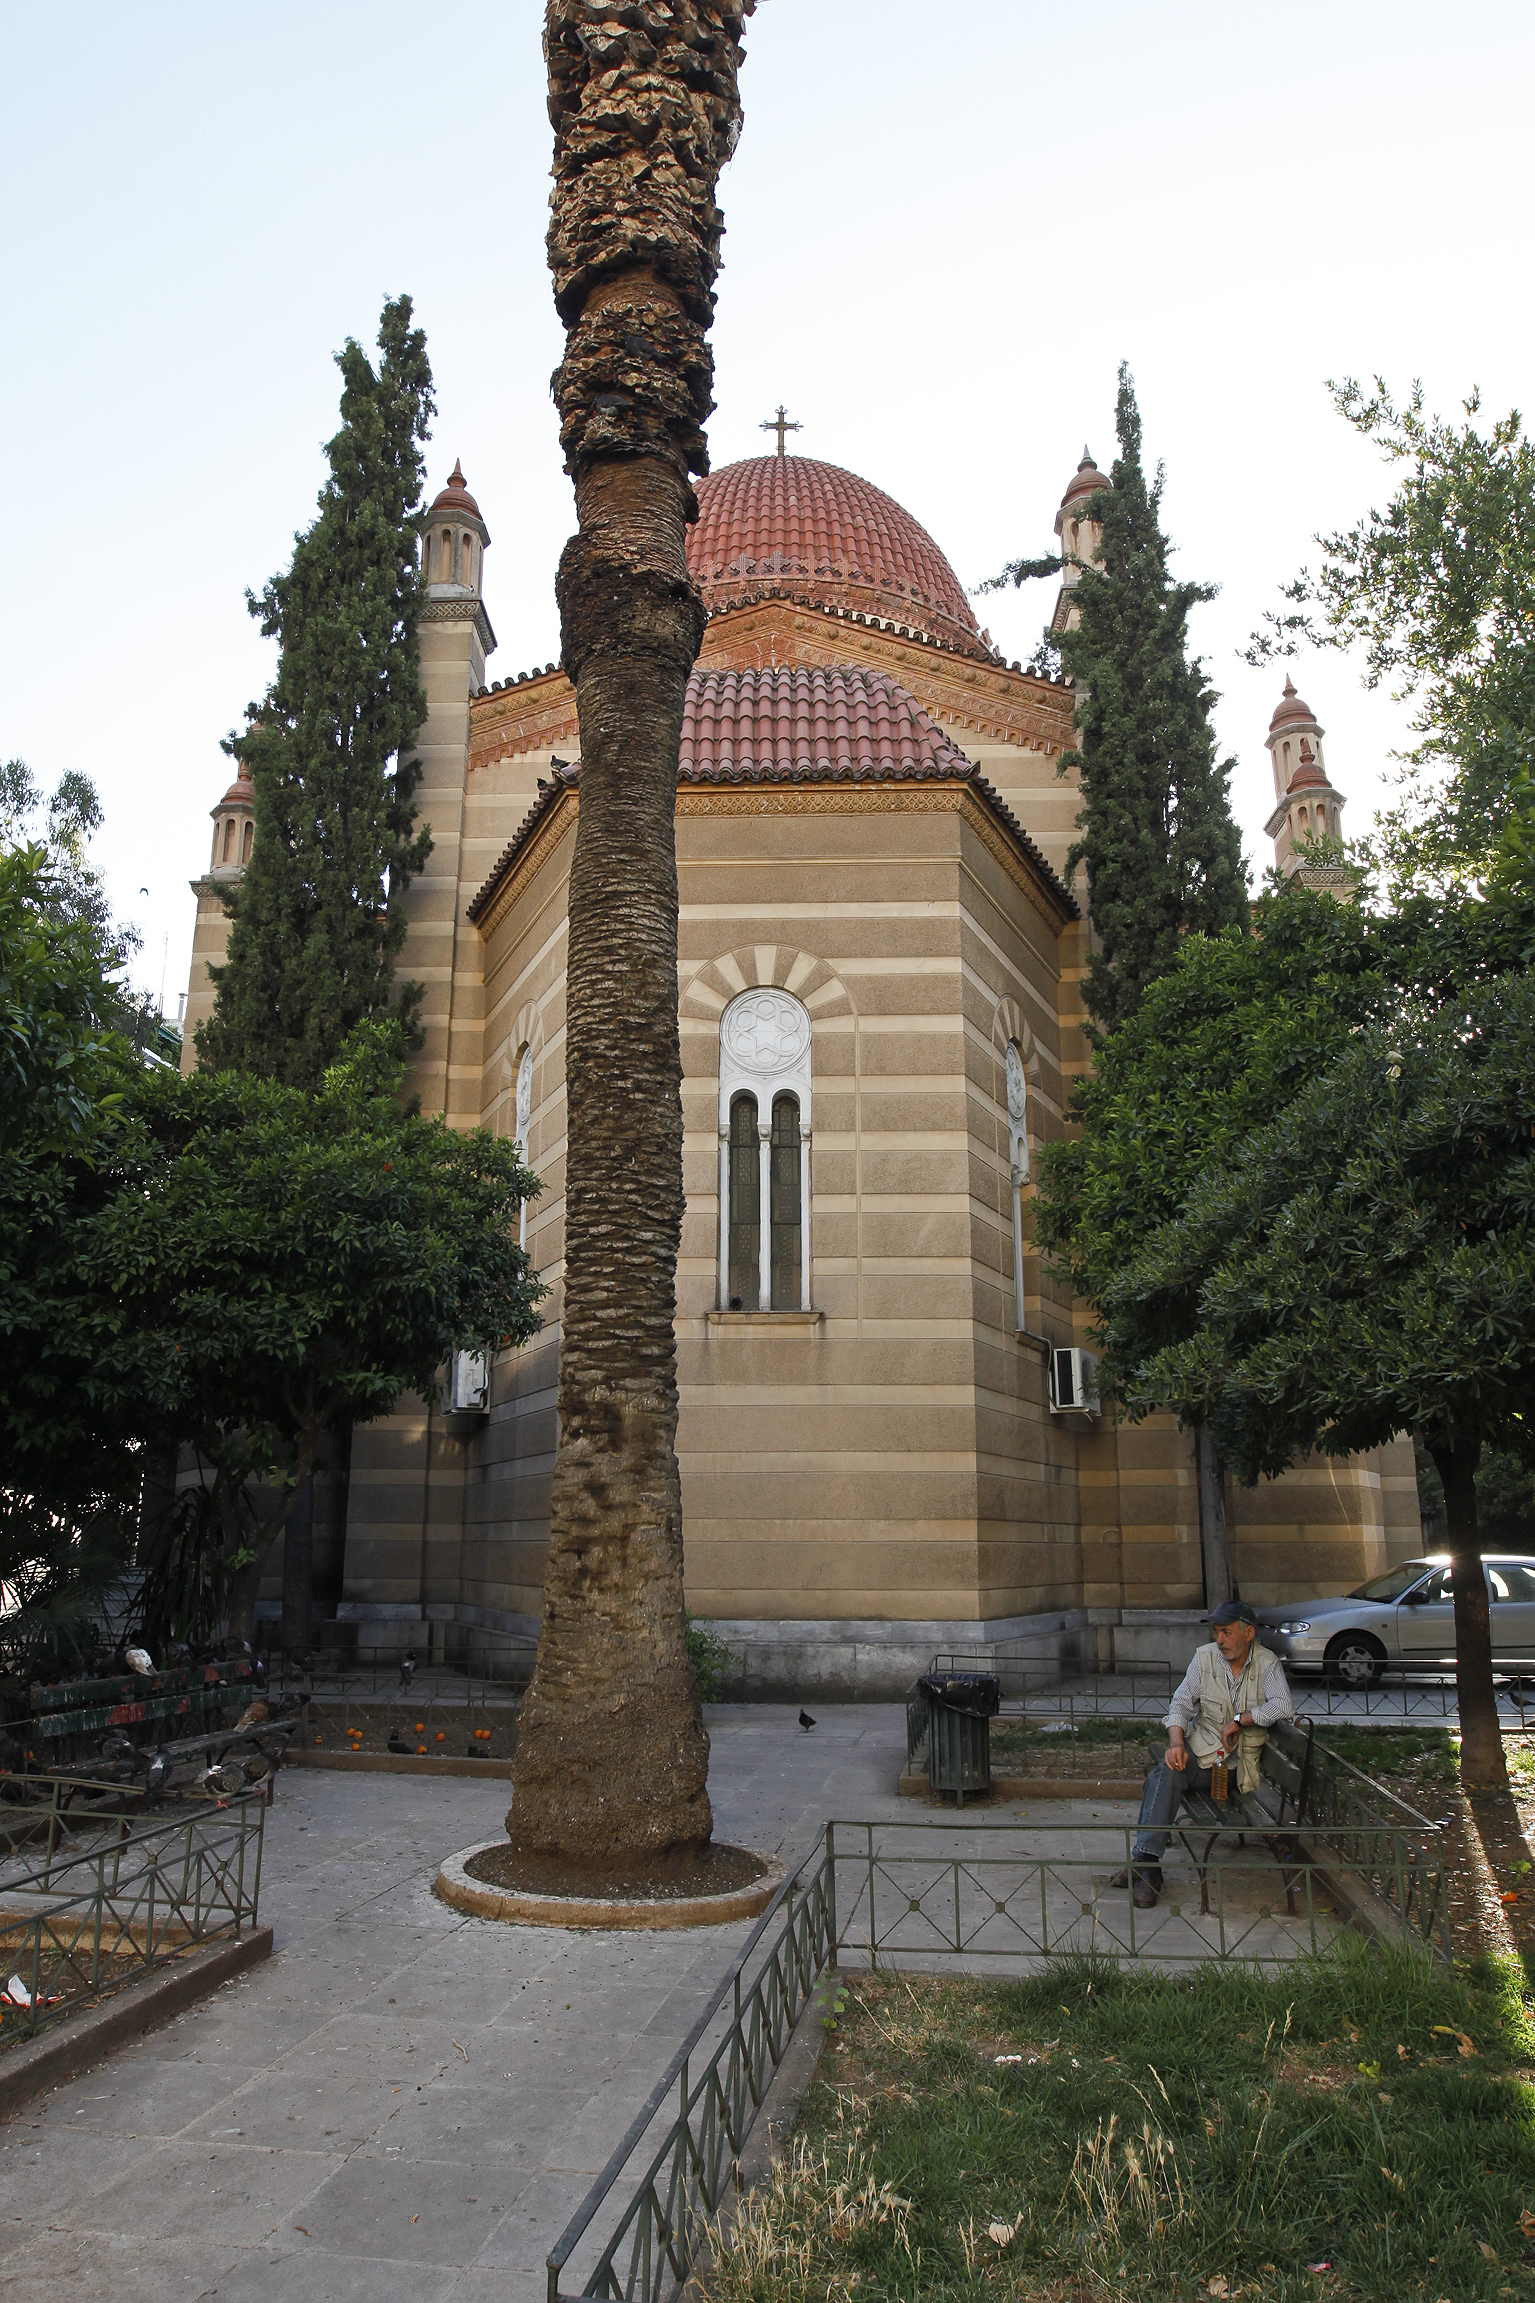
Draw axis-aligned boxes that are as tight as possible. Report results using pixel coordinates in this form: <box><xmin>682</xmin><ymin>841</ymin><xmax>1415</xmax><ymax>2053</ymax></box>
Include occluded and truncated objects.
<box><xmin>1109</xmin><ymin>1598</ymin><xmax>1296</xmax><ymax>1911</ymax></box>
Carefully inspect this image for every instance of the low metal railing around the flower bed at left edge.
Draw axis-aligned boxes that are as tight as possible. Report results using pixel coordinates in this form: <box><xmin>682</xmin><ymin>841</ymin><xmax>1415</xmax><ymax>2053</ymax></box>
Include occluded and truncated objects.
<box><xmin>0</xmin><ymin>1783</ymin><xmax>267</xmax><ymax>2040</ymax></box>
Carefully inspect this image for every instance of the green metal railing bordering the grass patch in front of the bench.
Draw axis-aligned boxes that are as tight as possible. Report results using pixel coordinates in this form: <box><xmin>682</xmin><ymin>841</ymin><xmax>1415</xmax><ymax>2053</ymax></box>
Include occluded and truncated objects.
<box><xmin>548</xmin><ymin>1810</ymin><xmax>1450</xmax><ymax>2303</ymax></box>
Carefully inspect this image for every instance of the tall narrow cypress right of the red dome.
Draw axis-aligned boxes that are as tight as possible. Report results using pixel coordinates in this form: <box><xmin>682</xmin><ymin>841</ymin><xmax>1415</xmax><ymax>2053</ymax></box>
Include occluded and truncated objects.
<box><xmin>984</xmin><ymin>366</ymin><xmax>1247</xmax><ymax>1029</ymax></box>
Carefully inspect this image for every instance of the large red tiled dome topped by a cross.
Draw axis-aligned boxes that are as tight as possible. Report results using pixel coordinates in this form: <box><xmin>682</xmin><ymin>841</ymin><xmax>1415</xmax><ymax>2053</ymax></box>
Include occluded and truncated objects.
<box><xmin>688</xmin><ymin>456</ymin><xmax>992</xmax><ymax>659</ymax></box>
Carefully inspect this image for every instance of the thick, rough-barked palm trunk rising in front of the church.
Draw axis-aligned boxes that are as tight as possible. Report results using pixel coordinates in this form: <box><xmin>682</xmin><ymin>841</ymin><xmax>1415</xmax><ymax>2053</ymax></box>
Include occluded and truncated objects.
<box><xmin>506</xmin><ymin>0</ymin><xmax>748</xmax><ymax>1865</ymax></box>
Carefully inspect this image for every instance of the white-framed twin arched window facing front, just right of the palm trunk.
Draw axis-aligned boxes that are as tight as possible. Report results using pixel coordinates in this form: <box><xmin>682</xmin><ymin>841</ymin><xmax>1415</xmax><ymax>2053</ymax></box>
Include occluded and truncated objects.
<box><xmin>718</xmin><ymin>983</ymin><xmax>810</xmax><ymax>1310</ymax></box>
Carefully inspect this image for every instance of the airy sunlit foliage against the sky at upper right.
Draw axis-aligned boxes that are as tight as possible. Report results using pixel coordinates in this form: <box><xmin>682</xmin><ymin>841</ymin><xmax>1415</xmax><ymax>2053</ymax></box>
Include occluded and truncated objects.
<box><xmin>1247</xmin><ymin>378</ymin><xmax>1535</xmax><ymax>889</ymax></box>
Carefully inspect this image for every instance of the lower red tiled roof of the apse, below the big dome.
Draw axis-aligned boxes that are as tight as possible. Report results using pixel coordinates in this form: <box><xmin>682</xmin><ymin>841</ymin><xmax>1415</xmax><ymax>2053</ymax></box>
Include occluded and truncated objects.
<box><xmin>469</xmin><ymin>666</ymin><xmax>1082</xmax><ymax>919</ymax></box>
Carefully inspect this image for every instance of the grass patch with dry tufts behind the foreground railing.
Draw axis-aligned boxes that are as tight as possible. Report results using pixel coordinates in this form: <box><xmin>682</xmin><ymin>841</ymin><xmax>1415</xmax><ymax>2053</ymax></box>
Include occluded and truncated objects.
<box><xmin>707</xmin><ymin>1941</ymin><xmax>1535</xmax><ymax>2303</ymax></box>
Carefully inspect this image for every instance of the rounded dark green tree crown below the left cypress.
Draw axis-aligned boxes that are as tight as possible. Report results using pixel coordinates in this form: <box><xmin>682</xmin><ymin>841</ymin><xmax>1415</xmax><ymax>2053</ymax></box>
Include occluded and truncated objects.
<box><xmin>0</xmin><ymin>1018</ymin><xmax>543</xmax><ymax>1639</ymax></box>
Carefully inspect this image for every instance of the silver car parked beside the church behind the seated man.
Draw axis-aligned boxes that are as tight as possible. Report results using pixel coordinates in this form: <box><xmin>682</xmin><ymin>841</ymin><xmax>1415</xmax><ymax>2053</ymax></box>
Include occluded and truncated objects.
<box><xmin>1257</xmin><ymin>1552</ymin><xmax>1535</xmax><ymax>1688</ymax></box>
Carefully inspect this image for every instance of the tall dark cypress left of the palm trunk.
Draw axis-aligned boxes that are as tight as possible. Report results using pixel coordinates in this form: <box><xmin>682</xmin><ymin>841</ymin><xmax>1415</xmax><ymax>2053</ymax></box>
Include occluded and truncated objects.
<box><xmin>198</xmin><ymin>297</ymin><xmax>433</xmax><ymax>1089</ymax></box>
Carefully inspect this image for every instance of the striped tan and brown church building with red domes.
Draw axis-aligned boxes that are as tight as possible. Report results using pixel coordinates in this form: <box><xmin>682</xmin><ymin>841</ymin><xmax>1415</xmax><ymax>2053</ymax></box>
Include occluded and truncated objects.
<box><xmin>186</xmin><ymin>431</ymin><xmax>1422</xmax><ymax>1695</ymax></box>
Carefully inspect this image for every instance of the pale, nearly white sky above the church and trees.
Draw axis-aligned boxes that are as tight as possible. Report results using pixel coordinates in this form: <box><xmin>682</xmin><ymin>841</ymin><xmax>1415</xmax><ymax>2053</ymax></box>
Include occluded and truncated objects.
<box><xmin>0</xmin><ymin>0</ymin><xmax>1535</xmax><ymax>1016</ymax></box>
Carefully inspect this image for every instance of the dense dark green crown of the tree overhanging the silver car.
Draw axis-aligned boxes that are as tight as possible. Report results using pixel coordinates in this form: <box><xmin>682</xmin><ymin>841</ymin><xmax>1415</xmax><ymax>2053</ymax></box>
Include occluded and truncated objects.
<box><xmin>1105</xmin><ymin>976</ymin><xmax>1535</xmax><ymax>1481</ymax></box>
